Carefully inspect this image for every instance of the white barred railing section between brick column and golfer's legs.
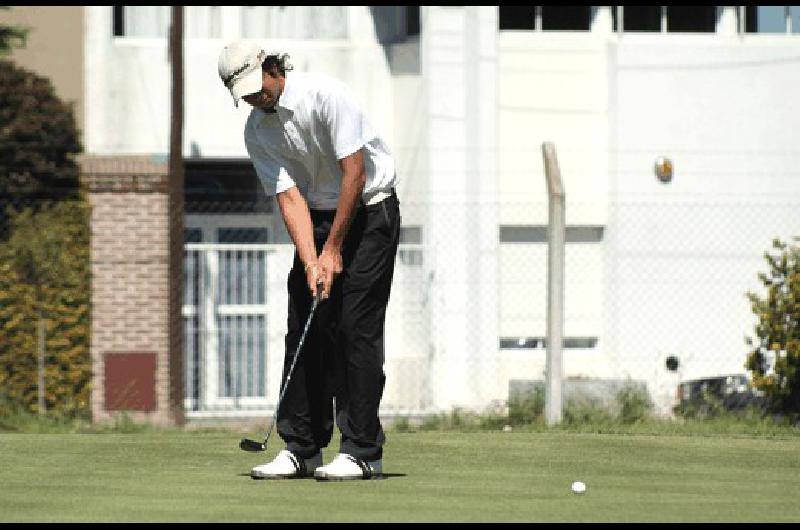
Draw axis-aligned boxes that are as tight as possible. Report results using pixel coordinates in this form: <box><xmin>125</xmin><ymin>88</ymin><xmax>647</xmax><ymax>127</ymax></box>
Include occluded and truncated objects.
<box><xmin>183</xmin><ymin>244</ymin><xmax>292</xmax><ymax>413</ymax></box>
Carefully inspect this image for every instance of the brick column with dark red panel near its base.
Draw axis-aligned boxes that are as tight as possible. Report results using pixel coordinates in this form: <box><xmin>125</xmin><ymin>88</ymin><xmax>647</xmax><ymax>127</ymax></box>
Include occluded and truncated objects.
<box><xmin>82</xmin><ymin>157</ymin><xmax>184</xmax><ymax>425</ymax></box>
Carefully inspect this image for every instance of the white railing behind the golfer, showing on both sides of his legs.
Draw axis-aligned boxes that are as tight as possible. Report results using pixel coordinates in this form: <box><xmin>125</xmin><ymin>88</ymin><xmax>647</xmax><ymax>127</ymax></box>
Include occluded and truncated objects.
<box><xmin>183</xmin><ymin>243</ymin><xmax>430</xmax><ymax>419</ymax></box>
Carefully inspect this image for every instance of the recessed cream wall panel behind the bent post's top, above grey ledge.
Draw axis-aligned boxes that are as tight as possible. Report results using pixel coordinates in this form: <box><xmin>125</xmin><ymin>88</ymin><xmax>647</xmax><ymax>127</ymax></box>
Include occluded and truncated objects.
<box><xmin>497</xmin><ymin>31</ymin><xmax>608</xmax><ymax>219</ymax></box>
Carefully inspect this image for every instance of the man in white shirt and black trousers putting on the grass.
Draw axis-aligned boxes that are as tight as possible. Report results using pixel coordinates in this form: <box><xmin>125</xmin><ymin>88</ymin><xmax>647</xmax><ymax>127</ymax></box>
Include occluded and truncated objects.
<box><xmin>218</xmin><ymin>41</ymin><xmax>400</xmax><ymax>480</ymax></box>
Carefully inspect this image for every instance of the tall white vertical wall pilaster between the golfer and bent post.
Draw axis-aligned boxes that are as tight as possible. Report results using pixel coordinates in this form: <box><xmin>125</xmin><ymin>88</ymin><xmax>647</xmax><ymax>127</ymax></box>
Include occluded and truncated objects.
<box><xmin>420</xmin><ymin>6</ymin><xmax>505</xmax><ymax>410</ymax></box>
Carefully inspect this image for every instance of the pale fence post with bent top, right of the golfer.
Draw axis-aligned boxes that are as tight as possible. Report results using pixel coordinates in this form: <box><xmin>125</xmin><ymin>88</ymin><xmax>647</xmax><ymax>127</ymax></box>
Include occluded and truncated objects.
<box><xmin>542</xmin><ymin>142</ymin><xmax>566</xmax><ymax>425</ymax></box>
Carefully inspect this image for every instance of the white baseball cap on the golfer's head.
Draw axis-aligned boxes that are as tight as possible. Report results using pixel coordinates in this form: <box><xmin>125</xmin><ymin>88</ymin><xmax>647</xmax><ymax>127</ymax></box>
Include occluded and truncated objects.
<box><xmin>217</xmin><ymin>41</ymin><xmax>267</xmax><ymax>107</ymax></box>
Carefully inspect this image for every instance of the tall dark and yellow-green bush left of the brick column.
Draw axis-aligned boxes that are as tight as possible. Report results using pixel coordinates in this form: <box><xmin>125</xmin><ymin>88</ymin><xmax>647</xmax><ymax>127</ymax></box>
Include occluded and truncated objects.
<box><xmin>0</xmin><ymin>41</ymin><xmax>91</xmax><ymax>416</ymax></box>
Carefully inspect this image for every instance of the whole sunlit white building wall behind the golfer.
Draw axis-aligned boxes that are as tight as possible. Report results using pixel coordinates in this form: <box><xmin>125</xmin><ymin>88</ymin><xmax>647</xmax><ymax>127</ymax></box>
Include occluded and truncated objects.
<box><xmin>85</xmin><ymin>6</ymin><xmax>800</xmax><ymax>409</ymax></box>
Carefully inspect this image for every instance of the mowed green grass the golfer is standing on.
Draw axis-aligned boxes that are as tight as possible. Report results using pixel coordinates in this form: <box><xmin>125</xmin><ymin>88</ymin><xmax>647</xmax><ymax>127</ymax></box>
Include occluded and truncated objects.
<box><xmin>0</xmin><ymin>431</ymin><xmax>800</xmax><ymax>522</ymax></box>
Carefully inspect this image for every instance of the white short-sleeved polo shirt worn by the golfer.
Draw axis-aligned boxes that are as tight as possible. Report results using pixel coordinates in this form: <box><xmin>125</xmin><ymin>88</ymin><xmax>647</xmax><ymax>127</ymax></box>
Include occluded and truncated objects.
<box><xmin>244</xmin><ymin>72</ymin><xmax>397</xmax><ymax>210</ymax></box>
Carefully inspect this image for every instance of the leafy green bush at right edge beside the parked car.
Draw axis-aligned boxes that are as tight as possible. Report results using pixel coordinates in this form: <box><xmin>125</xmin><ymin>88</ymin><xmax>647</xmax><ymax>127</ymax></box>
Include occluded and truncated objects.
<box><xmin>746</xmin><ymin>238</ymin><xmax>800</xmax><ymax>418</ymax></box>
